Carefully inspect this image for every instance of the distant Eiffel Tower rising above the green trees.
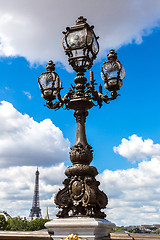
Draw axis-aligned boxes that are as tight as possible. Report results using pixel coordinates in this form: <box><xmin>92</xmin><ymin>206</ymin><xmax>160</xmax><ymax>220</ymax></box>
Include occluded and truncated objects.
<box><xmin>29</xmin><ymin>168</ymin><xmax>42</xmax><ymax>220</ymax></box>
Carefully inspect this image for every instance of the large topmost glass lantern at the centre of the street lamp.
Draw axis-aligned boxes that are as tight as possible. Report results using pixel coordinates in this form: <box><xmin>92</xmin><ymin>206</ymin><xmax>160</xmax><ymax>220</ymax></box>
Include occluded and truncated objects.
<box><xmin>62</xmin><ymin>16</ymin><xmax>99</xmax><ymax>72</ymax></box>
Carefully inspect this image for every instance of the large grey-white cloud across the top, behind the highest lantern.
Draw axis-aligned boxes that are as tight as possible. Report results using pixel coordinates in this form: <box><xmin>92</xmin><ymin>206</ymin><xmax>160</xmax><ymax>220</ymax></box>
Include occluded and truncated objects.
<box><xmin>0</xmin><ymin>0</ymin><xmax>160</xmax><ymax>64</ymax></box>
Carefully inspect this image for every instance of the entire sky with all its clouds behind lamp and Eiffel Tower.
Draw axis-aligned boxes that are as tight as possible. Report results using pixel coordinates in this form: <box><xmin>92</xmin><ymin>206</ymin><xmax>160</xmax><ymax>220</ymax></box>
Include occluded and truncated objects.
<box><xmin>0</xmin><ymin>0</ymin><xmax>160</xmax><ymax>228</ymax></box>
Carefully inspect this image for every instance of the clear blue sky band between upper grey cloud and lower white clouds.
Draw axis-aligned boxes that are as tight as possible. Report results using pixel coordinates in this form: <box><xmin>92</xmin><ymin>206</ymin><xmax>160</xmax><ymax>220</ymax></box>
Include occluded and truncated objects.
<box><xmin>0</xmin><ymin>27</ymin><xmax>160</xmax><ymax>172</ymax></box>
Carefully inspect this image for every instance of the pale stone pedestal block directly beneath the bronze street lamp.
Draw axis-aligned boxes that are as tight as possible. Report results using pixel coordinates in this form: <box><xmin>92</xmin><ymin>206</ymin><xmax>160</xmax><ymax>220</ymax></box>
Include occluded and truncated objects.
<box><xmin>45</xmin><ymin>217</ymin><xmax>115</xmax><ymax>240</ymax></box>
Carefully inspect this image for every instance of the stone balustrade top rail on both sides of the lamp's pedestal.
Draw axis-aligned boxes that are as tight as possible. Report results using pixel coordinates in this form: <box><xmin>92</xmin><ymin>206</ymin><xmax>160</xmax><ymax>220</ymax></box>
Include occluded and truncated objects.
<box><xmin>0</xmin><ymin>230</ymin><xmax>160</xmax><ymax>240</ymax></box>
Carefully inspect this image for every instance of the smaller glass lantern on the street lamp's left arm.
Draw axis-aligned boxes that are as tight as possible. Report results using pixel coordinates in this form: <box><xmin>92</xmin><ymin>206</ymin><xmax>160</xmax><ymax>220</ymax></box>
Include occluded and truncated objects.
<box><xmin>38</xmin><ymin>60</ymin><xmax>62</xmax><ymax>101</ymax></box>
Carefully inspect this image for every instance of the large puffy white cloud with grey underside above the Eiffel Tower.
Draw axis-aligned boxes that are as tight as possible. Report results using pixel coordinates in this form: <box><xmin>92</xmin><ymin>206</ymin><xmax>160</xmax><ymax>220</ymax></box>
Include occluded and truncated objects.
<box><xmin>0</xmin><ymin>101</ymin><xmax>70</xmax><ymax>167</ymax></box>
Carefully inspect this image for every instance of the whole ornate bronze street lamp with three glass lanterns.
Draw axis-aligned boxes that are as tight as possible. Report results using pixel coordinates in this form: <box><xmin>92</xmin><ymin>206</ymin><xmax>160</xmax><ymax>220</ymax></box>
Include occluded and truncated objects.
<box><xmin>38</xmin><ymin>16</ymin><xmax>125</xmax><ymax>219</ymax></box>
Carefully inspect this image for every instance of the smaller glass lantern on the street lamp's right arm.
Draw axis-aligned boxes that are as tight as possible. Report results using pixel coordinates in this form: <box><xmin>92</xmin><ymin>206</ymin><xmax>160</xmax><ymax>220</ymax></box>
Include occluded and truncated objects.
<box><xmin>101</xmin><ymin>49</ymin><xmax>125</xmax><ymax>91</ymax></box>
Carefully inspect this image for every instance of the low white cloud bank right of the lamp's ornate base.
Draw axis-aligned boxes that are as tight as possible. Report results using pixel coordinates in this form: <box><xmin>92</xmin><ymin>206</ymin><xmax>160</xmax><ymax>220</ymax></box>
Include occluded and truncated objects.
<box><xmin>98</xmin><ymin>157</ymin><xmax>160</xmax><ymax>226</ymax></box>
